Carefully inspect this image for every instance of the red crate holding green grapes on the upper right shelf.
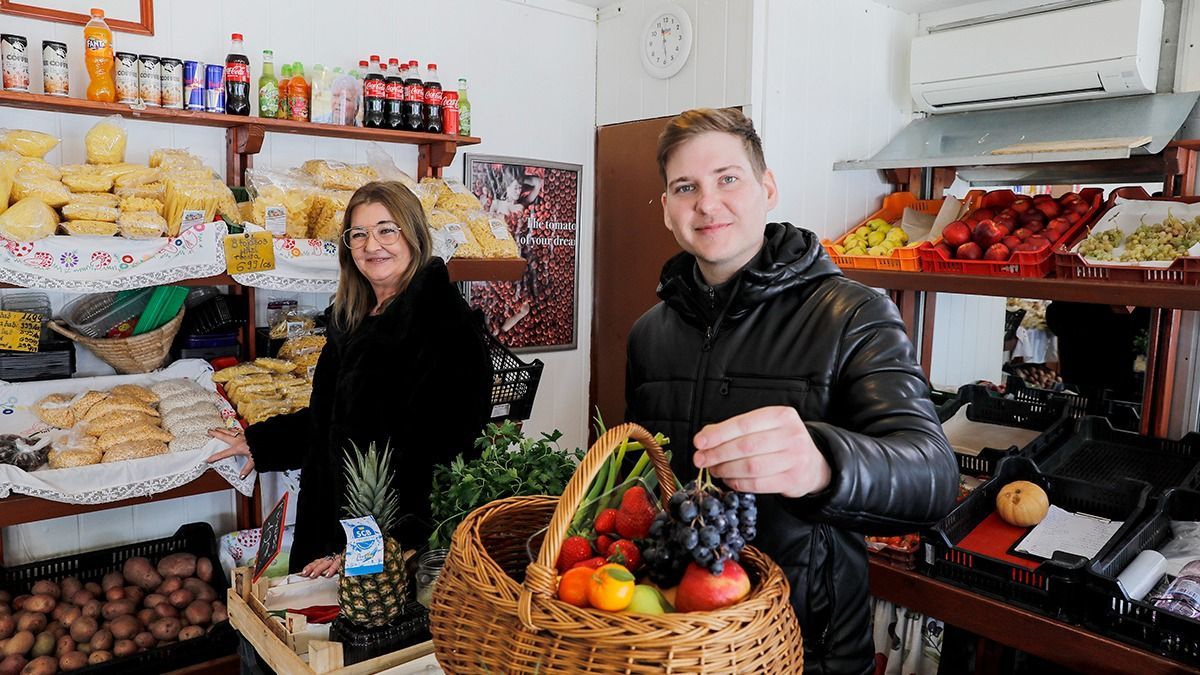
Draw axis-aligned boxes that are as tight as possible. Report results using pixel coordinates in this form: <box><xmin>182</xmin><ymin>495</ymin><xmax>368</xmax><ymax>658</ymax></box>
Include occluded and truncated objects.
<box><xmin>1054</xmin><ymin>186</ymin><xmax>1200</xmax><ymax>286</ymax></box>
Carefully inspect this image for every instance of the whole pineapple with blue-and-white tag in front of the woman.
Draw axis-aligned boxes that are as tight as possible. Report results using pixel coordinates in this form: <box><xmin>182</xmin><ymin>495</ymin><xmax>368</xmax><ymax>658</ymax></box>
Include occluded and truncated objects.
<box><xmin>337</xmin><ymin>443</ymin><xmax>408</xmax><ymax>628</ymax></box>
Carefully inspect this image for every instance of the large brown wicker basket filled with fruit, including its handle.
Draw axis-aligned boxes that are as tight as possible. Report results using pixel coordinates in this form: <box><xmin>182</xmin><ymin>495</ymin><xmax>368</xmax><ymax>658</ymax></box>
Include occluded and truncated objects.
<box><xmin>430</xmin><ymin>424</ymin><xmax>804</xmax><ymax>675</ymax></box>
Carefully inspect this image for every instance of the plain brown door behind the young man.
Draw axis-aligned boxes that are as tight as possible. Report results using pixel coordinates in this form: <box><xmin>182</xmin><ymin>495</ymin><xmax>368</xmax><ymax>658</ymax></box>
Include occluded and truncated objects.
<box><xmin>588</xmin><ymin>118</ymin><xmax>679</xmax><ymax>437</ymax></box>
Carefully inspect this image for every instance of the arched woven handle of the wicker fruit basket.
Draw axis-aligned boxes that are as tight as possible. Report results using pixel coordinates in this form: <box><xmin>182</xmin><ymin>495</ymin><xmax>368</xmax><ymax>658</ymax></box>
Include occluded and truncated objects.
<box><xmin>517</xmin><ymin>423</ymin><xmax>676</xmax><ymax>629</ymax></box>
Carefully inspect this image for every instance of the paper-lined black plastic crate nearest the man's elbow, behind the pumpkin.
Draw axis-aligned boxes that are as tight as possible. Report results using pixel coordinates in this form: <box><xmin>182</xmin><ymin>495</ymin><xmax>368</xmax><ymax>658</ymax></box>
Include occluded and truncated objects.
<box><xmin>937</xmin><ymin>384</ymin><xmax>1072</xmax><ymax>476</ymax></box>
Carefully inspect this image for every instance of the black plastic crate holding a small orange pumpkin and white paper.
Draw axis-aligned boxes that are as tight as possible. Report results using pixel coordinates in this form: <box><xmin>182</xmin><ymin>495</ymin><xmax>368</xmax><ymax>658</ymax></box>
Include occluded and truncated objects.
<box><xmin>923</xmin><ymin>456</ymin><xmax>1150</xmax><ymax>620</ymax></box>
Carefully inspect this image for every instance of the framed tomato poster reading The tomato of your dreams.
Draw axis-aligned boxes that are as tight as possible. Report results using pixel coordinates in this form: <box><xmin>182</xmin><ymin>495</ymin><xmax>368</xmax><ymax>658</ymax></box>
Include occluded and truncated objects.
<box><xmin>463</xmin><ymin>154</ymin><xmax>583</xmax><ymax>352</ymax></box>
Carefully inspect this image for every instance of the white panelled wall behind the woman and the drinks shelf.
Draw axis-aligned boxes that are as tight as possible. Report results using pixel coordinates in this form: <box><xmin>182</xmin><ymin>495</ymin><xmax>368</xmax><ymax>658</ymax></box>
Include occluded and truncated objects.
<box><xmin>0</xmin><ymin>0</ymin><xmax>596</xmax><ymax>565</ymax></box>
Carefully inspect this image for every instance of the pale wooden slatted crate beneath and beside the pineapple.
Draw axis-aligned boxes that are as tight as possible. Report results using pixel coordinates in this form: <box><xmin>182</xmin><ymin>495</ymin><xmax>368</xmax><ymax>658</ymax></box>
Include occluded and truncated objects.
<box><xmin>227</xmin><ymin>567</ymin><xmax>433</xmax><ymax>675</ymax></box>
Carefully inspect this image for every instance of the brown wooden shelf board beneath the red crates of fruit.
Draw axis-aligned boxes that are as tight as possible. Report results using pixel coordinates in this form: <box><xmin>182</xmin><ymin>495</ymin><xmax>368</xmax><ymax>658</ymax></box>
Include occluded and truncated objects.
<box><xmin>842</xmin><ymin>269</ymin><xmax>1200</xmax><ymax>310</ymax></box>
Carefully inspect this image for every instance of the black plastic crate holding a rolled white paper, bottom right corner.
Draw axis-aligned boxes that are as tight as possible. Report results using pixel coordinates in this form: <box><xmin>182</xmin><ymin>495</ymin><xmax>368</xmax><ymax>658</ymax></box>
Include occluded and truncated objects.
<box><xmin>1084</xmin><ymin>489</ymin><xmax>1200</xmax><ymax>668</ymax></box>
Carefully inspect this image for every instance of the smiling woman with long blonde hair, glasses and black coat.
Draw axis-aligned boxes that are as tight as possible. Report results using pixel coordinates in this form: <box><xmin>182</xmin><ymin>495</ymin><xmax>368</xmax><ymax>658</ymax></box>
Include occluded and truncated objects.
<box><xmin>209</xmin><ymin>181</ymin><xmax>492</xmax><ymax>577</ymax></box>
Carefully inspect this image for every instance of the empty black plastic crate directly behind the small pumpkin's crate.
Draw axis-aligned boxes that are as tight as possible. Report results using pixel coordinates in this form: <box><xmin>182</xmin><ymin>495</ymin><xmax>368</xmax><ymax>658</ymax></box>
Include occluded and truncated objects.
<box><xmin>1034</xmin><ymin>417</ymin><xmax>1200</xmax><ymax>496</ymax></box>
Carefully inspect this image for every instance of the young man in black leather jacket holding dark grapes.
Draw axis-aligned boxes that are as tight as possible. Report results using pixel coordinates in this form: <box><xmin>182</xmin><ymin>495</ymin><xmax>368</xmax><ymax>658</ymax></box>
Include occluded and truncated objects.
<box><xmin>625</xmin><ymin>109</ymin><xmax>959</xmax><ymax>675</ymax></box>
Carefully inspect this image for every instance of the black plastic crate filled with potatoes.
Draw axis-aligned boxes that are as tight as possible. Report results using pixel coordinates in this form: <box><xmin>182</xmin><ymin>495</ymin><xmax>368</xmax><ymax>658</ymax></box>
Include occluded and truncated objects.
<box><xmin>0</xmin><ymin>522</ymin><xmax>238</xmax><ymax>675</ymax></box>
